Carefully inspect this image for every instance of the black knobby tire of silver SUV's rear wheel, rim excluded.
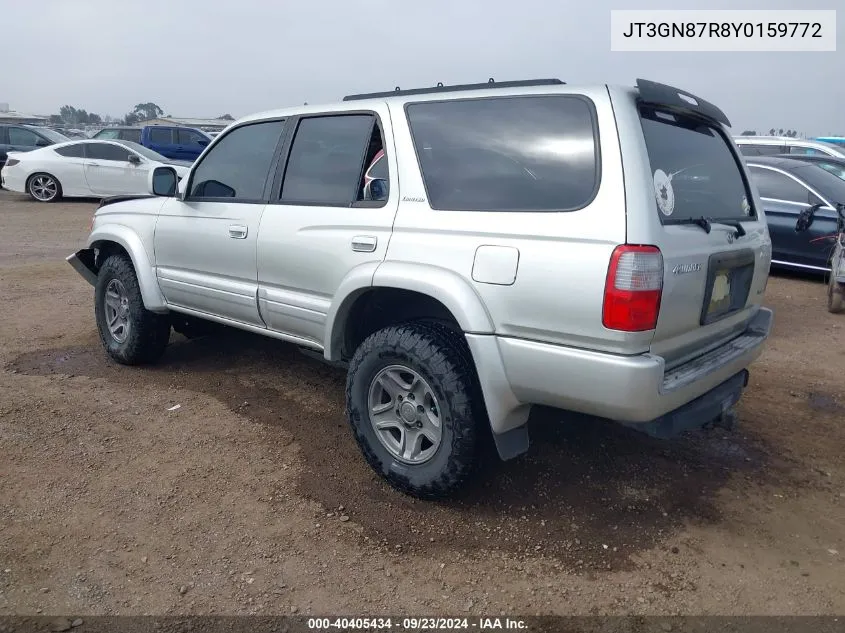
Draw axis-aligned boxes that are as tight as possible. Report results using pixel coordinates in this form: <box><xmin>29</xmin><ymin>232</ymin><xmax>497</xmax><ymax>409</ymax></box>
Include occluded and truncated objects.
<box><xmin>346</xmin><ymin>322</ymin><xmax>487</xmax><ymax>499</ymax></box>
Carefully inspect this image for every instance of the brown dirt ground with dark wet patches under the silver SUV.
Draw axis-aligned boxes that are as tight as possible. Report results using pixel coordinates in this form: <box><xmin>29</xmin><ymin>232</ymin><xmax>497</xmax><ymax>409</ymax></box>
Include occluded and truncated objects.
<box><xmin>0</xmin><ymin>192</ymin><xmax>845</xmax><ymax>616</ymax></box>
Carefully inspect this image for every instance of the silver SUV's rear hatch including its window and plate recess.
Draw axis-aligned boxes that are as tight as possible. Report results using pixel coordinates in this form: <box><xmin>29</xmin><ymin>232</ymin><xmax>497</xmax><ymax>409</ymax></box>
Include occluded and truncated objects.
<box><xmin>628</xmin><ymin>90</ymin><xmax>771</xmax><ymax>367</ymax></box>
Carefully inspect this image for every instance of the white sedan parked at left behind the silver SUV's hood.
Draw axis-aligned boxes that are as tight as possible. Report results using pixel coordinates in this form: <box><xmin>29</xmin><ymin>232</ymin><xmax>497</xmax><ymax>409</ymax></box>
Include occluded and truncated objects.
<box><xmin>0</xmin><ymin>140</ymin><xmax>191</xmax><ymax>202</ymax></box>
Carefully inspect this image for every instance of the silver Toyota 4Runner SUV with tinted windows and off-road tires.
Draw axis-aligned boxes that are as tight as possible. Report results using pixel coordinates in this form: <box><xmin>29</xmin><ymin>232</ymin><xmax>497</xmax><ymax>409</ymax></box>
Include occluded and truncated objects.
<box><xmin>68</xmin><ymin>75</ymin><xmax>772</xmax><ymax>498</ymax></box>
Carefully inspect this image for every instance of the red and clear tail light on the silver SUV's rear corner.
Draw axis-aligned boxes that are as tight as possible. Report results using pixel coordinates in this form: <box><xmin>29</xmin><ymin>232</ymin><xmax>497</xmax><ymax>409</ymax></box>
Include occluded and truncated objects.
<box><xmin>602</xmin><ymin>244</ymin><xmax>663</xmax><ymax>332</ymax></box>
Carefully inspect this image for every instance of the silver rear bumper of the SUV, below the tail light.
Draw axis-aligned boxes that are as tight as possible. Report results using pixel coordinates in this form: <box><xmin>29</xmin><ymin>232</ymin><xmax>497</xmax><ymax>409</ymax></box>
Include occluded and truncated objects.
<box><xmin>467</xmin><ymin>308</ymin><xmax>773</xmax><ymax>433</ymax></box>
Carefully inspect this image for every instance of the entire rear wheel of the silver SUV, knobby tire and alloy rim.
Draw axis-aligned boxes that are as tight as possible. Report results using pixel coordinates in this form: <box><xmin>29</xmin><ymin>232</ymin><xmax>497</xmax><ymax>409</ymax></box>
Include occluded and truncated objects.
<box><xmin>346</xmin><ymin>323</ymin><xmax>485</xmax><ymax>498</ymax></box>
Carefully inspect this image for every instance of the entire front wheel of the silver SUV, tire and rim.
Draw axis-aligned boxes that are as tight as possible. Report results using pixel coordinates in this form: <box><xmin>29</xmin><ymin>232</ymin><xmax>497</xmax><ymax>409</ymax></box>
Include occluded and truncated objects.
<box><xmin>94</xmin><ymin>255</ymin><xmax>170</xmax><ymax>365</ymax></box>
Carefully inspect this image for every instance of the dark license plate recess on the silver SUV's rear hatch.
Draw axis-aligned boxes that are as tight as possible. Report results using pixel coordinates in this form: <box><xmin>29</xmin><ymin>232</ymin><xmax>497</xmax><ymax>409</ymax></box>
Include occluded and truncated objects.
<box><xmin>701</xmin><ymin>250</ymin><xmax>754</xmax><ymax>325</ymax></box>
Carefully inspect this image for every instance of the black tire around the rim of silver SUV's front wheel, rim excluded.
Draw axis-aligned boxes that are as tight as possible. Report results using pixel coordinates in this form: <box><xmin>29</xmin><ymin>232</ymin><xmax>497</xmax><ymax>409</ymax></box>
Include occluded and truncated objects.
<box><xmin>94</xmin><ymin>255</ymin><xmax>170</xmax><ymax>365</ymax></box>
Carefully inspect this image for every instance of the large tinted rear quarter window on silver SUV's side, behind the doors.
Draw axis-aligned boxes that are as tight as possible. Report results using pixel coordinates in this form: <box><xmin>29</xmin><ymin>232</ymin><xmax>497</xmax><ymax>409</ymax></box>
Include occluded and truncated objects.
<box><xmin>406</xmin><ymin>95</ymin><xmax>600</xmax><ymax>211</ymax></box>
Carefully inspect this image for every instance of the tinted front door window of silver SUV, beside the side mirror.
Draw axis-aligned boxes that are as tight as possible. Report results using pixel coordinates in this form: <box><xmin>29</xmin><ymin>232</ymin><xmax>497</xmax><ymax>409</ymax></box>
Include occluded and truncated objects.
<box><xmin>190</xmin><ymin>121</ymin><xmax>285</xmax><ymax>202</ymax></box>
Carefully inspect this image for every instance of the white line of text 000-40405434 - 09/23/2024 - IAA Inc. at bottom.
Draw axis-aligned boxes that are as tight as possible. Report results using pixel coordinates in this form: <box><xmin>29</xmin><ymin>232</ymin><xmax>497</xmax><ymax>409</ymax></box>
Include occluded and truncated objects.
<box><xmin>307</xmin><ymin>617</ymin><xmax>527</xmax><ymax>631</ymax></box>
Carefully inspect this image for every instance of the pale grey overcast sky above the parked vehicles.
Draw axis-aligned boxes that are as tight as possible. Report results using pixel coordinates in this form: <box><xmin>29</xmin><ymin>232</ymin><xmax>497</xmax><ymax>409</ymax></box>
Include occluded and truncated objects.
<box><xmin>0</xmin><ymin>0</ymin><xmax>845</xmax><ymax>134</ymax></box>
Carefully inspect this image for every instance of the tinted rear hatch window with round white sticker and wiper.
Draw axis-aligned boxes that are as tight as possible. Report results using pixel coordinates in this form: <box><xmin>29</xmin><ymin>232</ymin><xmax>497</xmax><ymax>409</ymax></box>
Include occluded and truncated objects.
<box><xmin>640</xmin><ymin>107</ymin><xmax>755</xmax><ymax>223</ymax></box>
